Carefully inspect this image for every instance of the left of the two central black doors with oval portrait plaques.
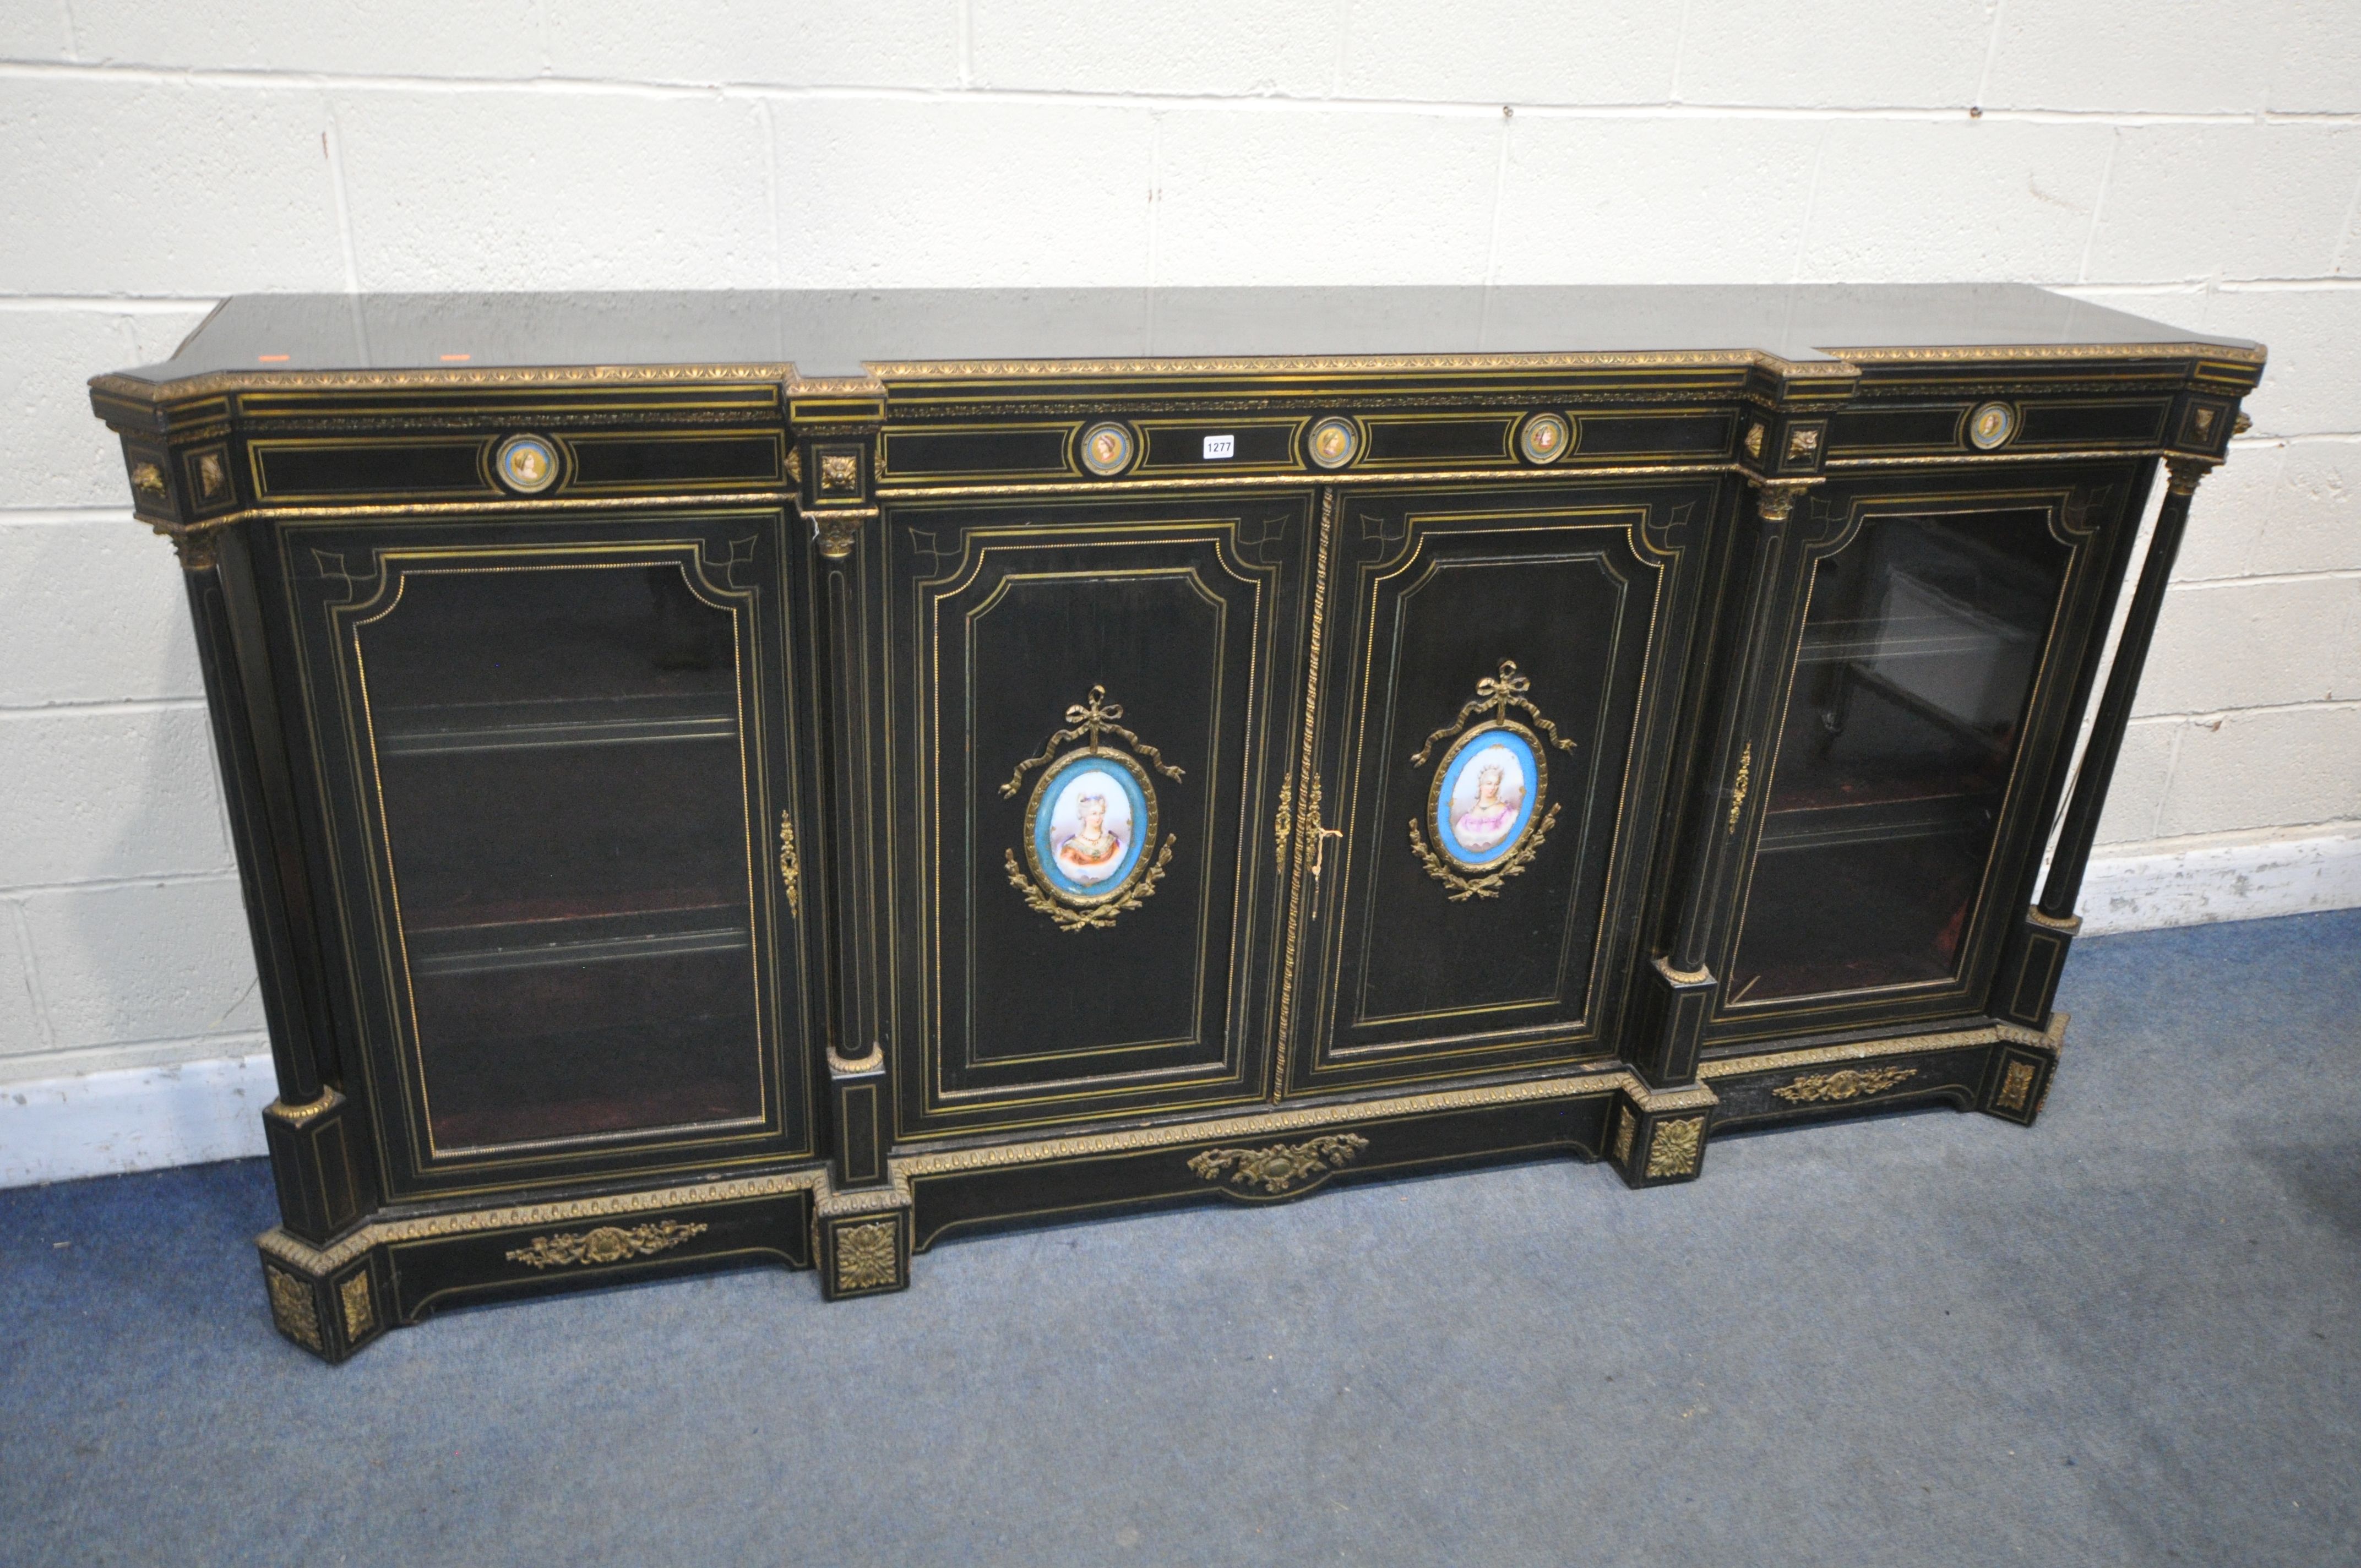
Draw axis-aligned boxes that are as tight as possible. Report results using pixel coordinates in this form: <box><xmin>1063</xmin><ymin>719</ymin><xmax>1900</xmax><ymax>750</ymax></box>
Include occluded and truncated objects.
<box><xmin>862</xmin><ymin>491</ymin><xmax>1313</xmax><ymax>1138</ymax></box>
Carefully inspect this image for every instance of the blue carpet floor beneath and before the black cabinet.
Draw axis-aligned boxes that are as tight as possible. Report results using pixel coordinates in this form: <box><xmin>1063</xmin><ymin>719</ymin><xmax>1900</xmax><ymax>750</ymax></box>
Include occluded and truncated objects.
<box><xmin>0</xmin><ymin>912</ymin><xmax>2361</xmax><ymax>1568</ymax></box>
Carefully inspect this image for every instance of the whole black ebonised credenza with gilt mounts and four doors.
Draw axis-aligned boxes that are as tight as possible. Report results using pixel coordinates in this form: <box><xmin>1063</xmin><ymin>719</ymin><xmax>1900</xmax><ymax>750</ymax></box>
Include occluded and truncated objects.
<box><xmin>92</xmin><ymin>286</ymin><xmax>2264</xmax><ymax>1360</ymax></box>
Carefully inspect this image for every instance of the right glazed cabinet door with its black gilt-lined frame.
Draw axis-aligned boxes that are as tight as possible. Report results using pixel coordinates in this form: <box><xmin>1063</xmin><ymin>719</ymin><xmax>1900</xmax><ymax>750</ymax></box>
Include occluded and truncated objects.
<box><xmin>1714</xmin><ymin>465</ymin><xmax>2137</xmax><ymax>1039</ymax></box>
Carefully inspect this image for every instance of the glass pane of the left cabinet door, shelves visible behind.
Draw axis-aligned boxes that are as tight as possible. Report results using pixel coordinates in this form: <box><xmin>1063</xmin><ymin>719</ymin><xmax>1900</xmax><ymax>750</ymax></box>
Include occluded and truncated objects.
<box><xmin>352</xmin><ymin>550</ymin><xmax>765</xmax><ymax>1152</ymax></box>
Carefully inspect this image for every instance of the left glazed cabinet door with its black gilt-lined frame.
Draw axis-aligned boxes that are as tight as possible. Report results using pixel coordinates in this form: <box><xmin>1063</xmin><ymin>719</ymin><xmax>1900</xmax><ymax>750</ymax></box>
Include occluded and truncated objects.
<box><xmin>279</xmin><ymin>510</ymin><xmax>810</xmax><ymax>1193</ymax></box>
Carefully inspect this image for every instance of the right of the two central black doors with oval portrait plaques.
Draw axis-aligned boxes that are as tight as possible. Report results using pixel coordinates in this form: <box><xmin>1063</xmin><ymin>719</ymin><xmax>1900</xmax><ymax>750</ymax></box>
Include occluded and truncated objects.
<box><xmin>1287</xmin><ymin>480</ymin><xmax>1721</xmax><ymax>1091</ymax></box>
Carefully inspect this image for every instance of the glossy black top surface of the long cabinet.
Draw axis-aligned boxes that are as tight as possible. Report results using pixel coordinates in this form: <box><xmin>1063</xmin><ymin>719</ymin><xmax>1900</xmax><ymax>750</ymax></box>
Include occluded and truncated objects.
<box><xmin>101</xmin><ymin>284</ymin><xmax>2262</xmax><ymax>385</ymax></box>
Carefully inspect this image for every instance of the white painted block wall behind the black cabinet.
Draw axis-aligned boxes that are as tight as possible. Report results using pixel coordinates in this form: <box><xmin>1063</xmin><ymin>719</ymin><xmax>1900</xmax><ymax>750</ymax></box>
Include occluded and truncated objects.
<box><xmin>0</xmin><ymin>0</ymin><xmax>2361</xmax><ymax>1181</ymax></box>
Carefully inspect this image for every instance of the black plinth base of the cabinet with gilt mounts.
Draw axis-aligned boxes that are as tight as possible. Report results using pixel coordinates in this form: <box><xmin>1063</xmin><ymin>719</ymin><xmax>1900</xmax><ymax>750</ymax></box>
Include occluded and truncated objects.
<box><xmin>260</xmin><ymin>1013</ymin><xmax>2066</xmax><ymax>1363</ymax></box>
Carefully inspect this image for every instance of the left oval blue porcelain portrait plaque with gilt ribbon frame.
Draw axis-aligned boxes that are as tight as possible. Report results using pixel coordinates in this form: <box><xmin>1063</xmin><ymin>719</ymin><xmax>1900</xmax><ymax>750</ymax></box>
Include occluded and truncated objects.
<box><xmin>1001</xmin><ymin>685</ymin><xmax>1183</xmax><ymax>930</ymax></box>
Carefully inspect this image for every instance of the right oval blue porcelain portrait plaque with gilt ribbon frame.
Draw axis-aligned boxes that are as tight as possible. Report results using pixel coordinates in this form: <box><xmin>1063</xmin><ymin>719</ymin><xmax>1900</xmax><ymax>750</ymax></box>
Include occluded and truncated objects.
<box><xmin>1410</xmin><ymin>659</ymin><xmax>1575</xmax><ymax>905</ymax></box>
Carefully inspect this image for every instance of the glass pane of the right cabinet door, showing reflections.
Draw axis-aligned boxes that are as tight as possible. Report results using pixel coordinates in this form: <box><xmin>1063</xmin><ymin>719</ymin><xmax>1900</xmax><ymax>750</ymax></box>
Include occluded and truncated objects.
<box><xmin>1728</xmin><ymin>510</ymin><xmax>2068</xmax><ymax>1006</ymax></box>
